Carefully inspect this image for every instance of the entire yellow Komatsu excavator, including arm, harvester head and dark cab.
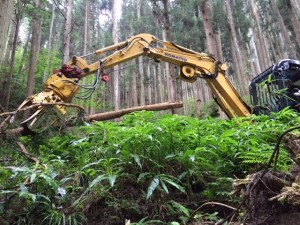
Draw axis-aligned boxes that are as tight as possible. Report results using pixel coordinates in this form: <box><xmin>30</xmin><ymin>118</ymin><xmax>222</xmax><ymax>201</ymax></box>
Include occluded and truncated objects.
<box><xmin>19</xmin><ymin>34</ymin><xmax>300</xmax><ymax>128</ymax></box>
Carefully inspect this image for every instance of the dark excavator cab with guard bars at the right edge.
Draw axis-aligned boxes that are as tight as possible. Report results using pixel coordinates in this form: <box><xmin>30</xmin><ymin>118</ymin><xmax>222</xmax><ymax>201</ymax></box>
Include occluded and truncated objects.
<box><xmin>249</xmin><ymin>59</ymin><xmax>300</xmax><ymax>115</ymax></box>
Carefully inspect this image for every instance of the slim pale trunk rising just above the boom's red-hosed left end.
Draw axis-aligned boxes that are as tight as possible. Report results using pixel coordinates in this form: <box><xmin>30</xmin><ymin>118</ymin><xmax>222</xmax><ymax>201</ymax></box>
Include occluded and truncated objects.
<box><xmin>63</xmin><ymin>0</ymin><xmax>73</xmax><ymax>63</ymax></box>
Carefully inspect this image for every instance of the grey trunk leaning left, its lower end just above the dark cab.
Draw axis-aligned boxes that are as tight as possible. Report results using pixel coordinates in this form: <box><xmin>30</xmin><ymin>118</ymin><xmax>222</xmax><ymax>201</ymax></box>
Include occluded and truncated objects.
<box><xmin>270</xmin><ymin>0</ymin><xmax>296</xmax><ymax>58</ymax></box>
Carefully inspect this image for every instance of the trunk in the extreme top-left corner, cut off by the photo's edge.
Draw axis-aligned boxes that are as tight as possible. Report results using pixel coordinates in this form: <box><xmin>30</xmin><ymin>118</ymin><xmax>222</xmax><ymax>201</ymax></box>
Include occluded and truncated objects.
<box><xmin>0</xmin><ymin>0</ymin><xmax>14</xmax><ymax>64</ymax></box>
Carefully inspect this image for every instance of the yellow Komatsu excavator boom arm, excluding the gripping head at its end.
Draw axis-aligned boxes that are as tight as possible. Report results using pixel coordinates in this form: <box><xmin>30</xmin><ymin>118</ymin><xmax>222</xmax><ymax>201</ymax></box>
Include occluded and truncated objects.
<box><xmin>69</xmin><ymin>34</ymin><xmax>251</xmax><ymax>118</ymax></box>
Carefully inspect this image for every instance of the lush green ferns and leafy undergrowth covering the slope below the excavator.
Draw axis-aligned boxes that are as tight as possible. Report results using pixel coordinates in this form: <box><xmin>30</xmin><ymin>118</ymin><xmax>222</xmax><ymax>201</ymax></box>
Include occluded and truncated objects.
<box><xmin>0</xmin><ymin>110</ymin><xmax>300</xmax><ymax>225</ymax></box>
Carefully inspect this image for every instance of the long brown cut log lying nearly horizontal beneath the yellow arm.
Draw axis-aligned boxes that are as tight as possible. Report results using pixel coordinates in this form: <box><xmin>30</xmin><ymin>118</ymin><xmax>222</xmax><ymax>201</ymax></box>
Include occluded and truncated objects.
<box><xmin>84</xmin><ymin>101</ymin><xmax>183</xmax><ymax>122</ymax></box>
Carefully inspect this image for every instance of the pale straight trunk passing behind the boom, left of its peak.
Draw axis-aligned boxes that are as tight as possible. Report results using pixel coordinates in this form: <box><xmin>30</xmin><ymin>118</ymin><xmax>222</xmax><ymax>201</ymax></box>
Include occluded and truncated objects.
<box><xmin>112</xmin><ymin>0</ymin><xmax>120</xmax><ymax>110</ymax></box>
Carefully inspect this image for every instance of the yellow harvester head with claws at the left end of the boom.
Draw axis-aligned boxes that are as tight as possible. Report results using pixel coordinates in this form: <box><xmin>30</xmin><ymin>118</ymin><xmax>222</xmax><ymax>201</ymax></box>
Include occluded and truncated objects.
<box><xmin>18</xmin><ymin>64</ymin><xmax>82</xmax><ymax>130</ymax></box>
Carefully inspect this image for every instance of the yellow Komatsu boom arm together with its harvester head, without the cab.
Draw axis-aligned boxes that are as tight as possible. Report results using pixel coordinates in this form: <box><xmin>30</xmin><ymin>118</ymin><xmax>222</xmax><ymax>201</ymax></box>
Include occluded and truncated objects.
<box><xmin>19</xmin><ymin>34</ymin><xmax>251</xmax><ymax>130</ymax></box>
